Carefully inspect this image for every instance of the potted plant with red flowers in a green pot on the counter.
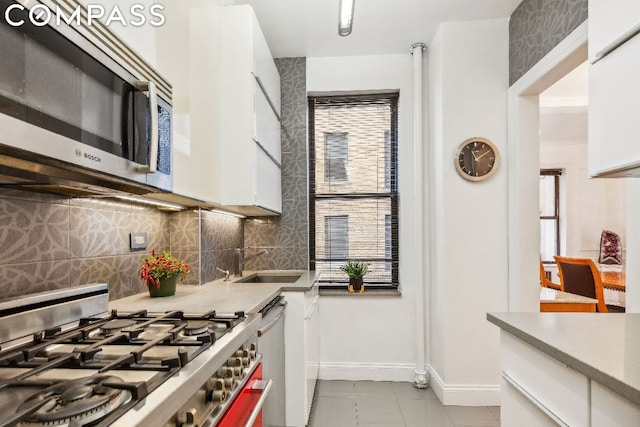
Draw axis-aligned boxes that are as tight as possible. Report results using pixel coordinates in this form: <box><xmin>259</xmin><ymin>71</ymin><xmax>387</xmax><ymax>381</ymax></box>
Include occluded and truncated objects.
<box><xmin>138</xmin><ymin>250</ymin><xmax>191</xmax><ymax>297</ymax></box>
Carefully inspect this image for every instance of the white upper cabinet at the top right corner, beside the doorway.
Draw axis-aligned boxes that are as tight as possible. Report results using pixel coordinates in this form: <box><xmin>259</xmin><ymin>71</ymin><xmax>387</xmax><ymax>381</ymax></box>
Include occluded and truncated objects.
<box><xmin>589</xmin><ymin>0</ymin><xmax>640</xmax><ymax>177</ymax></box>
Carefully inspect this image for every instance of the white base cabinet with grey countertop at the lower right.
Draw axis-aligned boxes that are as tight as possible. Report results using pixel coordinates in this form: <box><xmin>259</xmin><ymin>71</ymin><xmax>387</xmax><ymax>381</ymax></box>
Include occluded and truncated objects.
<box><xmin>487</xmin><ymin>313</ymin><xmax>640</xmax><ymax>427</ymax></box>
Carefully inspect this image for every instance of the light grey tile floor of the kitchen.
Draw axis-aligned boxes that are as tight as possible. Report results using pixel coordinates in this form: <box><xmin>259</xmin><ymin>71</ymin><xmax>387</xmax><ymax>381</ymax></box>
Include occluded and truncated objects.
<box><xmin>309</xmin><ymin>381</ymin><xmax>500</xmax><ymax>427</ymax></box>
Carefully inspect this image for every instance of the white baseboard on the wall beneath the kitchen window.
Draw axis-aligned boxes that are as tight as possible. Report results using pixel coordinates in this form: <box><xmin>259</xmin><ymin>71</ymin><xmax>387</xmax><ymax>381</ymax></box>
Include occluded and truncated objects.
<box><xmin>319</xmin><ymin>362</ymin><xmax>415</xmax><ymax>382</ymax></box>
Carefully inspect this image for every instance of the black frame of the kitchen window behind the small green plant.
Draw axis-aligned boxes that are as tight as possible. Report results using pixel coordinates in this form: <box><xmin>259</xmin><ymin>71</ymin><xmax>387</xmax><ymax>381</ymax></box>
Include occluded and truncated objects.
<box><xmin>308</xmin><ymin>92</ymin><xmax>400</xmax><ymax>289</ymax></box>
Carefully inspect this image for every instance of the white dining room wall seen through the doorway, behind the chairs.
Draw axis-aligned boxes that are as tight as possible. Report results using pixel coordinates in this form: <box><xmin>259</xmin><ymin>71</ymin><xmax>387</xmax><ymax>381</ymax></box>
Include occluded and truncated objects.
<box><xmin>540</xmin><ymin>140</ymin><xmax>626</xmax><ymax>260</ymax></box>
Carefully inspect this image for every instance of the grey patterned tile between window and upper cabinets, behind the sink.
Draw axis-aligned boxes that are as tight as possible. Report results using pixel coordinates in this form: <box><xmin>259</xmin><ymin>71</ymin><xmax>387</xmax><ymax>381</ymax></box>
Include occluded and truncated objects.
<box><xmin>244</xmin><ymin>58</ymin><xmax>309</xmax><ymax>270</ymax></box>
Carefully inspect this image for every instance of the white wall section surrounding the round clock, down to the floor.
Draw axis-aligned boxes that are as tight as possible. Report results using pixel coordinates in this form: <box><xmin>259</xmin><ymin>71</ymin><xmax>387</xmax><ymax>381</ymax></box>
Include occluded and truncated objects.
<box><xmin>427</xmin><ymin>20</ymin><xmax>508</xmax><ymax>405</ymax></box>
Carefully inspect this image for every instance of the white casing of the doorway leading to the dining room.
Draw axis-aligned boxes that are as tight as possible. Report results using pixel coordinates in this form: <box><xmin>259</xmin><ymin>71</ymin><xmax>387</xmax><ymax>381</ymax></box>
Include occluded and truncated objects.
<box><xmin>507</xmin><ymin>22</ymin><xmax>587</xmax><ymax>312</ymax></box>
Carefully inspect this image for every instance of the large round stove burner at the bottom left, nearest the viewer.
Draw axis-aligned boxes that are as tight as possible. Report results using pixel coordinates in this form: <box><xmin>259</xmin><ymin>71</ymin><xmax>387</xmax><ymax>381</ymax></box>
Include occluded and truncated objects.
<box><xmin>17</xmin><ymin>375</ymin><xmax>131</xmax><ymax>426</ymax></box>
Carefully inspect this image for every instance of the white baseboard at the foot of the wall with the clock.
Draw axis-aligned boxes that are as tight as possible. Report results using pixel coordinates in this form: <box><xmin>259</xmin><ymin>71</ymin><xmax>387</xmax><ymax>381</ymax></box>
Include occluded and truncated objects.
<box><xmin>428</xmin><ymin>366</ymin><xmax>500</xmax><ymax>406</ymax></box>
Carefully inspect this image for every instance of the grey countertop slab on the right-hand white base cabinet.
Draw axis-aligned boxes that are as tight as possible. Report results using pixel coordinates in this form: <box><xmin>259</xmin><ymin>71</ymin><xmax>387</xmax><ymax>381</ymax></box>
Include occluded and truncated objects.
<box><xmin>487</xmin><ymin>313</ymin><xmax>640</xmax><ymax>405</ymax></box>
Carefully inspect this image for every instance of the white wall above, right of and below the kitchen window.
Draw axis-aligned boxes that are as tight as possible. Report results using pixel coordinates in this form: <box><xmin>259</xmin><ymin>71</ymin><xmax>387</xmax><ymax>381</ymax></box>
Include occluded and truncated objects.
<box><xmin>307</xmin><ymin>54</ymin><xmax>424</xmax><ymax>381</ymax></box>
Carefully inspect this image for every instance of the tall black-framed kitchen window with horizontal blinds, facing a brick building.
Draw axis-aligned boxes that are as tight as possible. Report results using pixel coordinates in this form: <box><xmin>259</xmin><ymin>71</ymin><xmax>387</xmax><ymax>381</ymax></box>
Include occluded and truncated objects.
<box><xmin>309</xmin><ymin>93</ymin><xmax>398</xmax><ymax>288</ymax></box>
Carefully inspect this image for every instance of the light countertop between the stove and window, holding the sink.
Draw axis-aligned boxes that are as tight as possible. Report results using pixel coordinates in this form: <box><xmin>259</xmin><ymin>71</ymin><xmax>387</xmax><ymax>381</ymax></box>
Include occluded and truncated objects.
<box><xmin>109</xmin><ymin>270</ymin><xmax>316</xmax><ymax>314</ymax></box>
